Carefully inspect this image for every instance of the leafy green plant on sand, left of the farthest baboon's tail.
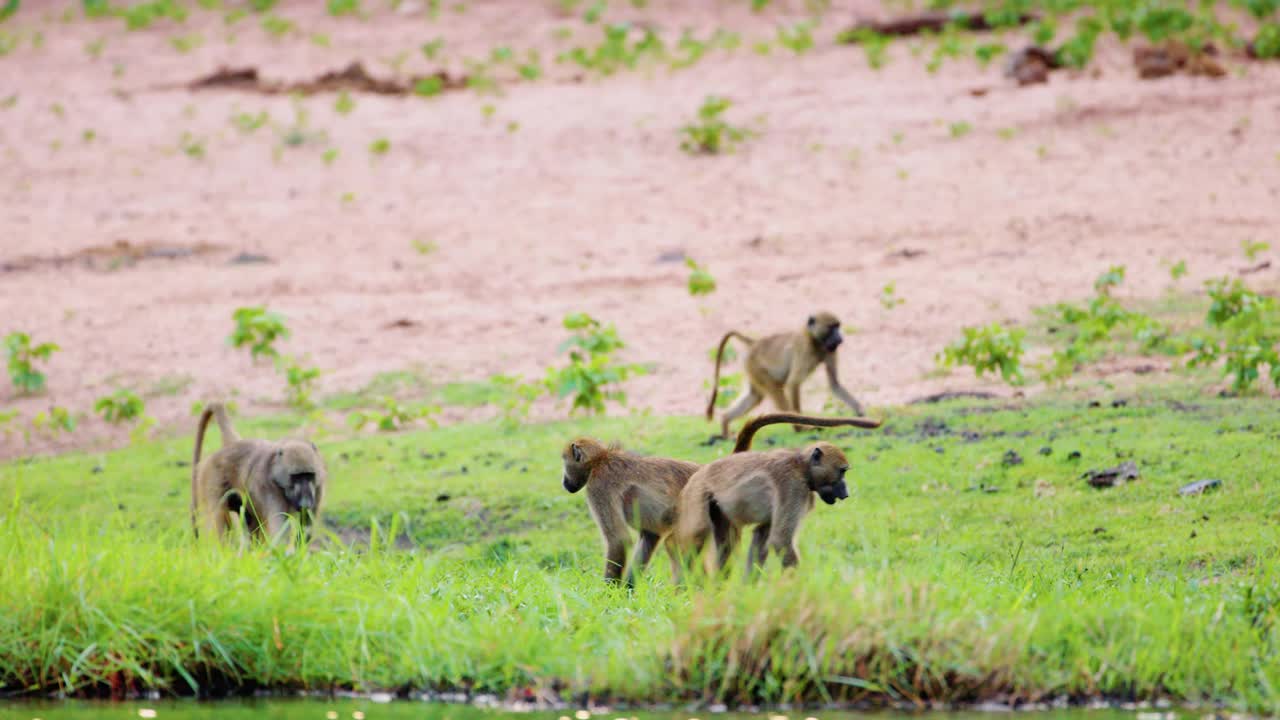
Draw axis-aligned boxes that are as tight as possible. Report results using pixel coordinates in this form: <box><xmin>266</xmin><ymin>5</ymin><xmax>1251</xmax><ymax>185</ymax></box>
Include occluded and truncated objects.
<box><xmin>545</xmin><ymin>313</ymin><xmax>648</xmax><ymax>414</ymax></box>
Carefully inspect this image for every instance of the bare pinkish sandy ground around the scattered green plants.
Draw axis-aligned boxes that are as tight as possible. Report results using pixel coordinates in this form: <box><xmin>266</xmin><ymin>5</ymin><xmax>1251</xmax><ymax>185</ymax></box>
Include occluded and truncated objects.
<box><xmin>0</xmin><ymin>0</ymin><xmax>1280</xmax><ymax>457</ymax></box>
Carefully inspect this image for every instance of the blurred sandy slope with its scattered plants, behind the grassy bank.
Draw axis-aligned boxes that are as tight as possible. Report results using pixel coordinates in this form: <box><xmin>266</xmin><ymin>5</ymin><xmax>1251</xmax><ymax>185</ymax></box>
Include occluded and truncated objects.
<box><xmin>0</xmin><ymin>0</ymin><xmax>1280</xmax><ymax>457</ymax></box>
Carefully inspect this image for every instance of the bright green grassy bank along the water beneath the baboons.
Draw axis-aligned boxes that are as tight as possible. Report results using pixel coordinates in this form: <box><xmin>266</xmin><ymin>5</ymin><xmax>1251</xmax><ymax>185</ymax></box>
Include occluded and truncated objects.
<box><xmin>0</xmin><ymin>392</ymin><xmax>1280</xmax><ymax>711</ymax></box>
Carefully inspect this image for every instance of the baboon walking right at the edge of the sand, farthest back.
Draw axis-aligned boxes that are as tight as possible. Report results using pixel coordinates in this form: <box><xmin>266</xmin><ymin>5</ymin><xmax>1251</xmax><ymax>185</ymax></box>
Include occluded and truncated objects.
<box><xmin>707</xmin><ymin>313</ymin><xmax>863</xmax><ymax>439</ymax></box>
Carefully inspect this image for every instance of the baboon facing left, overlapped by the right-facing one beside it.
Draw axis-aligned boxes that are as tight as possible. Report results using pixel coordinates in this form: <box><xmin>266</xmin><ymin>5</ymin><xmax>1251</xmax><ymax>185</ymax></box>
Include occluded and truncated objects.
<box><xmin>562</xmin><ymin>413</ymin><xmax>879</xmax><ymax>588</ymax></box>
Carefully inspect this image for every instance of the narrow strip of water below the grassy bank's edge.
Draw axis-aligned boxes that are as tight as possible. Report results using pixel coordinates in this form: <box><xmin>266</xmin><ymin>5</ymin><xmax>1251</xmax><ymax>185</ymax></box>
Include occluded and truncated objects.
<box><xmin>0</xmin><ymin>700</ymin><xmax>1141</xmax><ymax>720</ymax></box>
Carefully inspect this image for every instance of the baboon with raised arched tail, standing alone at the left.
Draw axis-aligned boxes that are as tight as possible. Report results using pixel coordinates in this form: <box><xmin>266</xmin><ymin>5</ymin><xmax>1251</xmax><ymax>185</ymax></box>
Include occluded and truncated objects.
<box><xmin>191</xmin><ymin>402</ymin><xmax>328</xmax><ymax>538</ymax></box>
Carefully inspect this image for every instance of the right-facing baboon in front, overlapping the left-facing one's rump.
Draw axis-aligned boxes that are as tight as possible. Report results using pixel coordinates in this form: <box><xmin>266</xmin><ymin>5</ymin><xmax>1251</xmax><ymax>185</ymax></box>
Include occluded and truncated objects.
<box><xmin>672</xmin><ymin>419</ymin><xmax>879</xmax><ymax>573</ymax></box>
